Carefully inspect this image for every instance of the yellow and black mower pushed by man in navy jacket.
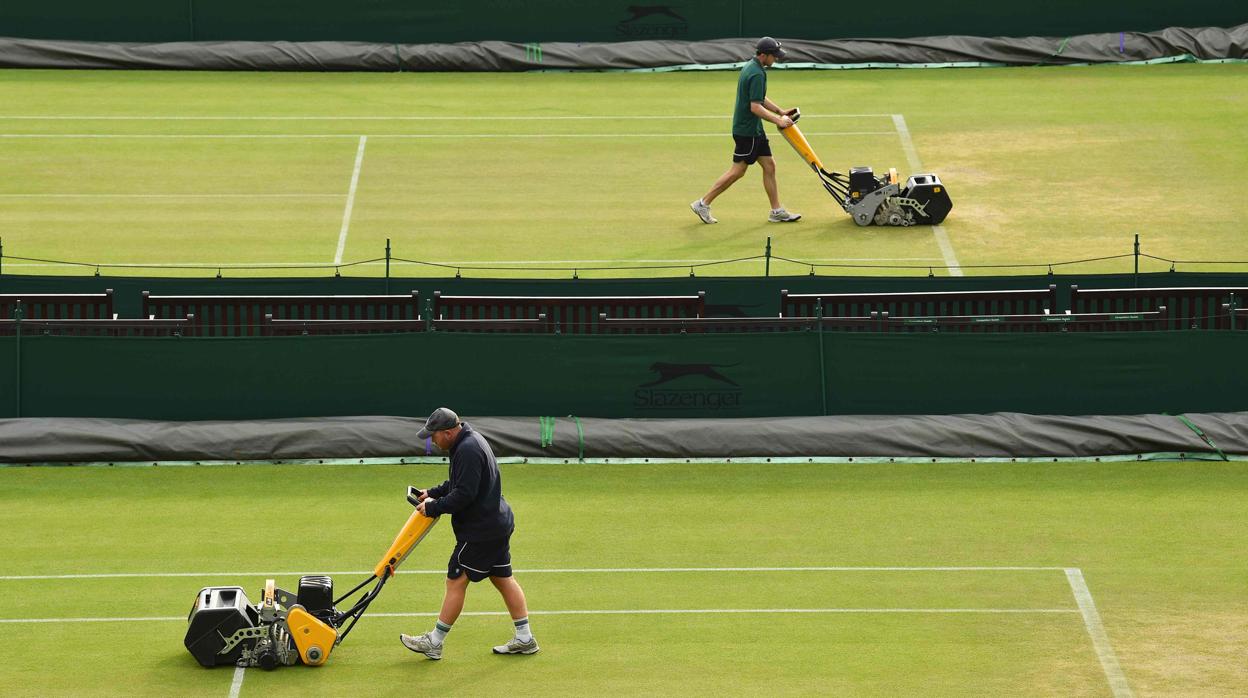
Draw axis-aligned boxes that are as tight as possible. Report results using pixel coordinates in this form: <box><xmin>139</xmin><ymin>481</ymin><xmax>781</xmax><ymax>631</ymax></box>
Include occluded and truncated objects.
<box><xmin>183</xmin><ymin>487</ymin><xmax>437</xmax><ymax>669</ymax></box>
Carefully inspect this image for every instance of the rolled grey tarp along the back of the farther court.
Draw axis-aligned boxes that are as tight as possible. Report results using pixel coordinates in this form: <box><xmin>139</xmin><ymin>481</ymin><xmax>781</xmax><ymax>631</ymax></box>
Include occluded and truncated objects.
<box><xmin>0</xmin><ymin>24</ymin><xmax>1248</xmax><ymax>71</ymax></box>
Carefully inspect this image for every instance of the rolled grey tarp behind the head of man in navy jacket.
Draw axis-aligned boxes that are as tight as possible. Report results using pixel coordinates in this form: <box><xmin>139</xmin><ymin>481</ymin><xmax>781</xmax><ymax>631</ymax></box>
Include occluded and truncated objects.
<box><xmin>0</xmin><ymin>412</ymin><xmax>1248</xmax><ymax>465</ymax></box>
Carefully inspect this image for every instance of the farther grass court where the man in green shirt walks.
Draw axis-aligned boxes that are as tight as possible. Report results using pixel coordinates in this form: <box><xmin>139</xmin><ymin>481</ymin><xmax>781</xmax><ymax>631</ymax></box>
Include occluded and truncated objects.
<box><xmin>0</xmin><ymin>65</ymin><xmax>1248</xmax><ymax>277</ymax></box>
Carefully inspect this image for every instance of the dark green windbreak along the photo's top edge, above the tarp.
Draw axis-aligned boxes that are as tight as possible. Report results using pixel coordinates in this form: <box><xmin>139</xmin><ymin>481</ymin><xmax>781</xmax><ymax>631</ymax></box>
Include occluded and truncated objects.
<box><xmin>0</xmin><ymin>0</ymin><xmax>1244</xmax><ymax>44</ymax></box>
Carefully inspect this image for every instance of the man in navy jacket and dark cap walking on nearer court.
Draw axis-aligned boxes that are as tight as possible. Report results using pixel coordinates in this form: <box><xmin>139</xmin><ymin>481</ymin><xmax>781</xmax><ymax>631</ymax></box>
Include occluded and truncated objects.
<box><xmin>398</xmin><ymin>407</ymin><xmax>539</xmax><ymax>659</ymax></box>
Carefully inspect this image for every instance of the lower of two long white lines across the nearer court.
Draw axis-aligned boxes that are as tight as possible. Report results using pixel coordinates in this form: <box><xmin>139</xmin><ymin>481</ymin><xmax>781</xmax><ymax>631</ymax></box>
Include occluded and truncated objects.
<box><xmin>0</xmin><ymin>608</ymin><xmax>1078</xmax><ymax>624</ymax></box>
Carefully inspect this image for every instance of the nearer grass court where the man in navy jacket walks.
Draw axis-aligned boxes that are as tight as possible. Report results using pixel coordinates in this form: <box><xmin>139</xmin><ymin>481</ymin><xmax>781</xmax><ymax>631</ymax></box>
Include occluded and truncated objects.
<box><xmin>0</xmin><ymin>462</ymin><xmax>1248</xmax><ymax>697</ymax></box>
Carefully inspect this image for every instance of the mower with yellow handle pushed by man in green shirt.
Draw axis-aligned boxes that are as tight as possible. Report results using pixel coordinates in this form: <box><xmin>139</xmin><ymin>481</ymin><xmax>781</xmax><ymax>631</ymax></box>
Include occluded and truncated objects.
<box><xmin>780</xmin><ymin>109</ymin><xmax>953</xmax><ymax>226</ymax></box>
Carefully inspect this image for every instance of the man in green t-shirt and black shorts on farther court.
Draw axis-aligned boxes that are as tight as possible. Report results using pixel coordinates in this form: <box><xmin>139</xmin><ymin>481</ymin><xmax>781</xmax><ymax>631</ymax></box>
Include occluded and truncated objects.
<box><xmin>689</xmin><ymin>36</ymin><xmax>801</xmax><ymax>224</ymax></box>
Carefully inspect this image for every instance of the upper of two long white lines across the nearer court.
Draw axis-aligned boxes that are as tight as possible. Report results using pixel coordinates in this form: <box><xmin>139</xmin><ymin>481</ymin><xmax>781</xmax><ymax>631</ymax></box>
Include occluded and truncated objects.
<box><xmin>0</xmin><ymin>566</ymin><xmax>1067</xmax><ymax>582</ymax></box>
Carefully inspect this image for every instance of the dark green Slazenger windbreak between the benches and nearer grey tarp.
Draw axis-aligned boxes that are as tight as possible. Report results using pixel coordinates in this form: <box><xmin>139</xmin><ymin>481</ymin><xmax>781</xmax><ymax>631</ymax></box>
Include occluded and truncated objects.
<box><xmin>0</xmin><ymin>330</ymin><xmax>1248</xmax><ymax>421</ymax></box>
